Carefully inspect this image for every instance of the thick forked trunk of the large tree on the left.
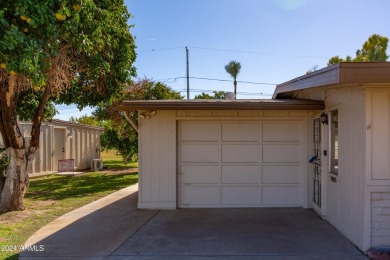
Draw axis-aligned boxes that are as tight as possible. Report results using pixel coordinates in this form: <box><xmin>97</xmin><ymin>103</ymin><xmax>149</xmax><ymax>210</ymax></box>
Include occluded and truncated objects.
<box><xmin>0</xmin><ymin>75</ymin><xmax>51</xmax><ymax>212</ymax></box>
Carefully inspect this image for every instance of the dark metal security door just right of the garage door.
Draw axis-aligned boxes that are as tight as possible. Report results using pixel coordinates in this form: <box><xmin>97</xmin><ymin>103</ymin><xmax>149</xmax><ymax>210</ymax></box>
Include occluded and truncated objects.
<box><xmin>310</xmin><ymin>118</ymin><xmax>323</xmax><ymax>216</ymax></box>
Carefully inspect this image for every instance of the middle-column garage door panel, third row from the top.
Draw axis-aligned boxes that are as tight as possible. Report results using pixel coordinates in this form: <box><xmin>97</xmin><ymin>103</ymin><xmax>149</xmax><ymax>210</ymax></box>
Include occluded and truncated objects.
<box><xmin>222</xmin><ymin>165</ymin><xmax>260</xmax><ymax>184</ymax></box>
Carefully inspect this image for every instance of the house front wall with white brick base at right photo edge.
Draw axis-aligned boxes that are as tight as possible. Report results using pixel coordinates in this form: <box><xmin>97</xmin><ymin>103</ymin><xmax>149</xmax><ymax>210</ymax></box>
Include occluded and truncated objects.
<box><xmin>364</xmin><ymin>89</ymin><xmax>390</xmax><ymax>249</ymax></box>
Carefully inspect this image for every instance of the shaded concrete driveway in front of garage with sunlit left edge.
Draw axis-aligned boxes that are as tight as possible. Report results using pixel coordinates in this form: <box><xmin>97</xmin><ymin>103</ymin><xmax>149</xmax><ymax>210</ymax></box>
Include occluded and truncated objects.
<box><xmin>20</xmin><ymin>186</ymin><xmax>367</xmax><ymax>259</ymax></box>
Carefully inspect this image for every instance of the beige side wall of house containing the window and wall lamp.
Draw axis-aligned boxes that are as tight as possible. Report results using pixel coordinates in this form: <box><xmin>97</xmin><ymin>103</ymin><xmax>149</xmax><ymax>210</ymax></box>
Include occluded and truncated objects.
<box><xmin>297</xmin><ymin>86</ymin><xmax>366</xmax><ymax>250</ymax></box>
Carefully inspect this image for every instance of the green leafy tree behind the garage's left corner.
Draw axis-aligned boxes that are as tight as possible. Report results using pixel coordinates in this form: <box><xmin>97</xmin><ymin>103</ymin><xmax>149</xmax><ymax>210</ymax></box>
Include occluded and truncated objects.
<box><xmin>92</xmin><ymin>78</ymin><xmax>183</xmax><ymax>162</ymax></box>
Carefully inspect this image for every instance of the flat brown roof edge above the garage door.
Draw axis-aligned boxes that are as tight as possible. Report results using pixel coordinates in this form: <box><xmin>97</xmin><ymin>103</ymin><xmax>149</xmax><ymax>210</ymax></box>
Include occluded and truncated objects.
<box><xmin>118</xmin><ymin>99</ymin><xmax>325</xmax><ymax>111</ymax></box>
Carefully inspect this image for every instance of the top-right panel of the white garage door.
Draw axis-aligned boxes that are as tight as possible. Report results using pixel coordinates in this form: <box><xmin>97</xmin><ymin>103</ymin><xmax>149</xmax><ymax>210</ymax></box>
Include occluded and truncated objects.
<box><xmin>262</xmin><ymin>122</ymin><xmax>301</xmax><ymax>142</ymax></box>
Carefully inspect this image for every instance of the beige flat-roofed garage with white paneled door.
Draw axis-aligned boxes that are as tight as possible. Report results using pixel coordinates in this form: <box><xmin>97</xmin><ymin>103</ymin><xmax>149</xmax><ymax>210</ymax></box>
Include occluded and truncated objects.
<box><xmin>117</xmin><ymin>100</ymin><xmax>324</xmax><ymax>209</ymax></box>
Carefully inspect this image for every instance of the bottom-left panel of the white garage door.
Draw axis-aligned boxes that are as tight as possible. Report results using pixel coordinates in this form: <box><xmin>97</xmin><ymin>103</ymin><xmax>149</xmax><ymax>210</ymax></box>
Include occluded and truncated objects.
<box><xmin>180</xmin><ymin>186</ymin><xmax>221</xmax><ymax>206</ymax></box>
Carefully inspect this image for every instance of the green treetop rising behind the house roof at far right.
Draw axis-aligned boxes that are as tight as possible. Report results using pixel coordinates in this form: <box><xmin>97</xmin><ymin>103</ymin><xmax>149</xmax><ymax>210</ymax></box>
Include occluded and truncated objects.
<box><xmin>328</xmin><ymin>34</ymin><xmax>389</xmax><ymax>66</ymax></box>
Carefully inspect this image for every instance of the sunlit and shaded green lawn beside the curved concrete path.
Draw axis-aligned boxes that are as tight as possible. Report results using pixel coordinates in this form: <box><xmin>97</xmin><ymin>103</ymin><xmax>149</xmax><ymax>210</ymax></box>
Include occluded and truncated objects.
<box><xmin>0</xmin><ymin>151</ymin><xmax>138</xmax><ymax>259</ymax></box>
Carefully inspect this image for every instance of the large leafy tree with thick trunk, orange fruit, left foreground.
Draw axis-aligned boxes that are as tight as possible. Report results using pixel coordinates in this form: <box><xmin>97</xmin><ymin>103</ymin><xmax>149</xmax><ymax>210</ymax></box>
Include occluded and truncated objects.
<box><xmin>0</xmin><ymin>0</ymin><xmax>136</xmax><ymax>212</ymax></box>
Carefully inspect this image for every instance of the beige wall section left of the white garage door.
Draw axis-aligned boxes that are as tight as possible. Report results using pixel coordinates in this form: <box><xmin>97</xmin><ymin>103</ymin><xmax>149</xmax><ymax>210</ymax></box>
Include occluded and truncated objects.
<box><xmin>138</xmin><ymin>111</ymin><xmax>176</xmax><ymax>209</ymax></box>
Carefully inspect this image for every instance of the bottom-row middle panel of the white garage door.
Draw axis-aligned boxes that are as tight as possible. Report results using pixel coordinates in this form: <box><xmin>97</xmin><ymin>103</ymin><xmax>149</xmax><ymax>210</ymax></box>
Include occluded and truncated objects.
<box><xmin>222</xmin><ymin>187</ymin><xmax>259</xmax><ymax>206</ymax></box>
